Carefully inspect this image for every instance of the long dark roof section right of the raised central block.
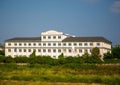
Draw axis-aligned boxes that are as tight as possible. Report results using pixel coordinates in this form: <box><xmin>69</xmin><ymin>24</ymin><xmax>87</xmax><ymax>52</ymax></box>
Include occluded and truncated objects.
<box><xmin>63</xmin><ymin>37</ymin><xmax>112</xmax><ymax>44</ymax></box>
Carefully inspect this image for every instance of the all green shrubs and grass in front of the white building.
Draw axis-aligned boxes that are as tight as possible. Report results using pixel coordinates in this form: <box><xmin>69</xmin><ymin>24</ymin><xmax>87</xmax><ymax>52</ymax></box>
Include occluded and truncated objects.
<box><xmin>0</xmin><ymin>46</ymin><xmax>120</xmax><ymax>85</ymax></box>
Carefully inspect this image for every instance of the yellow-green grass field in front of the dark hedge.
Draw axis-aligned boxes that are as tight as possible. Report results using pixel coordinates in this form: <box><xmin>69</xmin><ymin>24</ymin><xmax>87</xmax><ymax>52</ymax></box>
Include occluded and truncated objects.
<box><xmin>0</xmin><ymin>63</ymin><xmax>120</xmax><ymax>85</ymax></box>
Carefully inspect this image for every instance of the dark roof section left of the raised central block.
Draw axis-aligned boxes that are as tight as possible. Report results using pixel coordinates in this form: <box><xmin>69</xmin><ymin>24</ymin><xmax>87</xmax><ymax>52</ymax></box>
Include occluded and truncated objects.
<box><xmin>6</xmin><ymin>37</ymin><xmax>41</xmax><ymax>42</ymax></box>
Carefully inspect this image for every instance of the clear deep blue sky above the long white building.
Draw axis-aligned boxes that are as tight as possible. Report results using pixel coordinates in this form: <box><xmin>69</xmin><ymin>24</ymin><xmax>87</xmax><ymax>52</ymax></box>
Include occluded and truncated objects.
<box><xmin>0</xmin><ymin>0</ymin><xmax>120</xmax><ymax>45</ymax></box>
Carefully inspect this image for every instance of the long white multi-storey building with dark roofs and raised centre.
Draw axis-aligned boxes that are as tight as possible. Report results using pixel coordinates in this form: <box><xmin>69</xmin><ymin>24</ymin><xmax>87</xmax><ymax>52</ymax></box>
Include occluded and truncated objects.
<box><xmin>5</xmin><ymin>30</ymin><xmax>112</xmax><ymax>58</ymax></box>
